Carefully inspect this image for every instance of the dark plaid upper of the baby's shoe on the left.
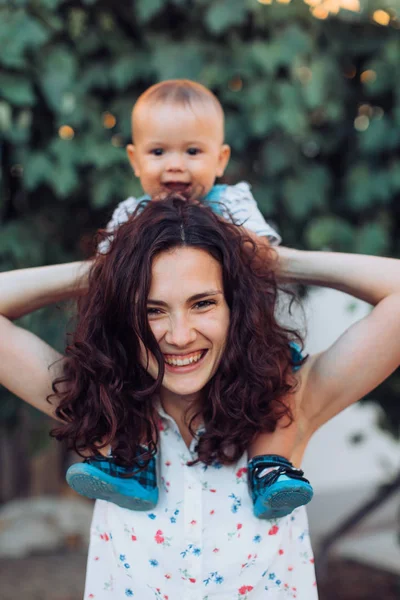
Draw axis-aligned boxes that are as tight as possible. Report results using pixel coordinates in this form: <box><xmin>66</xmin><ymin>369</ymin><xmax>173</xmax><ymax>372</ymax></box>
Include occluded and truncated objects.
<box><xmin>84</xmin><ymin>447</ymin><xmax>157</xmax><ymax>490</ymax></box>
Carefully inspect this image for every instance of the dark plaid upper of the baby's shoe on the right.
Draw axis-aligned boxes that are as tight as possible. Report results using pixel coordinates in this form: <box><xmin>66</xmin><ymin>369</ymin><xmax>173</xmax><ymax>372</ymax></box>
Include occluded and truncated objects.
<box><xmin>247</xmin><ymin>454</ymin><xmax>310</xmax><ymax>504</ymax></box>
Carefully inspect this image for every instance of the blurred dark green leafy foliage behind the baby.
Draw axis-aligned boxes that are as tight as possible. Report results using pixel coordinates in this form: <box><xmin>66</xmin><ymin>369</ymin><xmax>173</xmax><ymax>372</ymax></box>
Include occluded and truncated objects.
<box><xmin>0</xmin><ymin>0</ymin><xmax>400</xmax><ymax>434</ymax></box>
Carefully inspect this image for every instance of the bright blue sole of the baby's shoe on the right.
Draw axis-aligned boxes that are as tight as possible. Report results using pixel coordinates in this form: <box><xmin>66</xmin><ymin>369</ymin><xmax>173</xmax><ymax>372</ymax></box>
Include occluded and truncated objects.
<box><xmin>254</xmin><ymin>482</ymin><xmax>314</xmax><ymax>519</ymax></box>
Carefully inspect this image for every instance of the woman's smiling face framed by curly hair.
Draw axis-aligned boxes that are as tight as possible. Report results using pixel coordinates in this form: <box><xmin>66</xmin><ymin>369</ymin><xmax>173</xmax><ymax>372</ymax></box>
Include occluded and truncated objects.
<box><xmin>143</xmin><ymin>247</ymin><xmax>229</xmax><ymax>398</ymax></box>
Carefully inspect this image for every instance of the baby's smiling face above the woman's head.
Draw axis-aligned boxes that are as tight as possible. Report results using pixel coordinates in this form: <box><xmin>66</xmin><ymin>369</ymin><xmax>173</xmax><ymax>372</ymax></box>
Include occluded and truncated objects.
<box><xmin>127</xmin><ymin>103</ymin><xmax>230</xmax><ymax>197</ymax></box>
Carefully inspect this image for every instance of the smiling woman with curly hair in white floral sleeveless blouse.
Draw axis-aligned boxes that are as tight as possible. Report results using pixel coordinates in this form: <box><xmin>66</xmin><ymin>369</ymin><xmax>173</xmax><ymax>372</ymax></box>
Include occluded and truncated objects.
<box><xmin>0</xmin><ymin>197</ymin><xmax>400</xmax><ymax>600</ymax></box>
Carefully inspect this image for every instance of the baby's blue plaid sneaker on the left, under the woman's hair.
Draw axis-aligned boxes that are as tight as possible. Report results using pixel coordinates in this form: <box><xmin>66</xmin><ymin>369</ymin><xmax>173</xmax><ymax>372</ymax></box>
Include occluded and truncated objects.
<box><xmin>65</xmin><ymin>456</ymin><xmax>158</xmax><ymax>510</ymax></box>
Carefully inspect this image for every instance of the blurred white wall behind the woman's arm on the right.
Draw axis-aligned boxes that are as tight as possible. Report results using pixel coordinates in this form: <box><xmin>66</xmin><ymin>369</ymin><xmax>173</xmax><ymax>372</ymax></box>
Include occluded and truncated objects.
<box><xmin>296</xmin><ymin>288</ymin><xmax>400</xmax><ymax>541</ymax></box>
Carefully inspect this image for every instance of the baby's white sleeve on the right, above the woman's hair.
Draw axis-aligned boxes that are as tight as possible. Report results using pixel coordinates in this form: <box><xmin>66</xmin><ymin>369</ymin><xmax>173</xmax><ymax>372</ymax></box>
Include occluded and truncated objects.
<box><xmin>220</xmin><ymin>181</ymin><xmax>282</xmax><ymax>246</ymax></box>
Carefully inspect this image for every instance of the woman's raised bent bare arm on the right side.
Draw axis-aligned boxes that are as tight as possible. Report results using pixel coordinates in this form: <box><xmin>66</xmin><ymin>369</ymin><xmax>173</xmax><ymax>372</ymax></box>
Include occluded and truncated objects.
<box><xmin>277</xmin><ymin>248</ymin><xmax>400</xmax><ymax>430</ymax></box>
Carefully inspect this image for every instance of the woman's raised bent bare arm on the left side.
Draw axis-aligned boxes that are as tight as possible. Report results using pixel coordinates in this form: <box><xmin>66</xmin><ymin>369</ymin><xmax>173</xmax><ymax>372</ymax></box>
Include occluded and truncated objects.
<box><xmin>0</xmin><ymin>262</ymin><xmax>90</xmax><ymax>416</ymax></box>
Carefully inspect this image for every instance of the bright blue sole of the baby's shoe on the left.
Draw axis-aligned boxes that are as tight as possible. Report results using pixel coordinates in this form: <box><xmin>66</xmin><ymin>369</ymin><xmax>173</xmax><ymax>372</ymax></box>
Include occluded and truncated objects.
<box><xmin>66</xmin><ymin>463</ymin><xmax>158</xmax><ymax>511</ymax></box>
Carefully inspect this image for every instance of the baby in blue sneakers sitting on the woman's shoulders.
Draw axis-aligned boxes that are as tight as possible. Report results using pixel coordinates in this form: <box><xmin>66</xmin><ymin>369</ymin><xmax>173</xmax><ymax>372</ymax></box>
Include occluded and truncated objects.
<box><xmin>67</xmin><ymin>80</ymin><xmax>313</xmax><ymax>519</ymax></box>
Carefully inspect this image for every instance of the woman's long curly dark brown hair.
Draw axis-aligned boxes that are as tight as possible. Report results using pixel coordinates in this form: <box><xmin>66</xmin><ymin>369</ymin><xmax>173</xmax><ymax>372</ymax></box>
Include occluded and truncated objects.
<box><xmin>53</xmin><ymin>194</ymin><xmax>302</xmax><ymax>466</ymax></box>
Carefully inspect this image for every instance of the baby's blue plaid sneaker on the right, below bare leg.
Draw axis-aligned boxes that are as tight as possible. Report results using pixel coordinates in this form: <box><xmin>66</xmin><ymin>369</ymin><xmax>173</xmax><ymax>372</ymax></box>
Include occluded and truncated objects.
<box><xmin>248</xmin><ymin>454</ymin><xmax>314</xmax><ymax>519</ymax></box>
